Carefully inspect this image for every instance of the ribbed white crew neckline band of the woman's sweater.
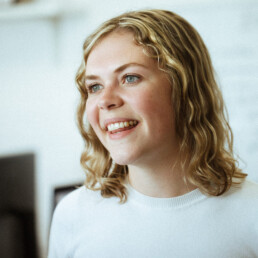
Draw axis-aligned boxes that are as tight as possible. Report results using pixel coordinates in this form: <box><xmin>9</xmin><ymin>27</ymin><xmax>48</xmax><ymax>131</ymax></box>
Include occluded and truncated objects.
<box><xmin>126</xmin><ymin>183</ymin><xmax>207</xmax><ymax>209</ymax></box>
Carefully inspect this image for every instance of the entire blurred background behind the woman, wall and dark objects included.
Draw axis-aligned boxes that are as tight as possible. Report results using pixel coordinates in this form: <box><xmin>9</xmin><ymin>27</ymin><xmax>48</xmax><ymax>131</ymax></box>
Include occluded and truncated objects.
<box><xmin>0</xmin><ymin>0</ymin><xmax>258</xmax><ymax>258</ymax></box>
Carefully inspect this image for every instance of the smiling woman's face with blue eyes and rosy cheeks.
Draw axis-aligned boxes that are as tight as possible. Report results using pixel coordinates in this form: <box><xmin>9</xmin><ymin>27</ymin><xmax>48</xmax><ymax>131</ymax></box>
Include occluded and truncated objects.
<box><xmin>86</xmin><ymin>31</ymin><xmax>177</xmax><ymax>165</ymax></box>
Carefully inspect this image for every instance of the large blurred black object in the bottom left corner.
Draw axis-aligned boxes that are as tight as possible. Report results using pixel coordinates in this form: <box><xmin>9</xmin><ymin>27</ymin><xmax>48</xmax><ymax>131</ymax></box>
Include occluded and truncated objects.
<box><xmin>0</xmin><ymin>153</ymin><xmax>38</xmax><ymax>258</ymax></box>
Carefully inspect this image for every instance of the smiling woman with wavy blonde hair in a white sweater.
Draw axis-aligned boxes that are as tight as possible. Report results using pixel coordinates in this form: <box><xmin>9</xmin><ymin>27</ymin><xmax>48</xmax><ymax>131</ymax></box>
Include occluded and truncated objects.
<box><xmin>49</xmin><ymin>10</ymin><xmax>258</xmax><ymax>258</ymax></box>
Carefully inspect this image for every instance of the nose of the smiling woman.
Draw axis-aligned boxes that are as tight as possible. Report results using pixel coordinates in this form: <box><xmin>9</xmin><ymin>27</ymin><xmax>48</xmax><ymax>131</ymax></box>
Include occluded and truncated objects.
<box><xmin>98</xmin><ymin>87</ymin><xmax>123</xmax><ymax>110</ymax></box>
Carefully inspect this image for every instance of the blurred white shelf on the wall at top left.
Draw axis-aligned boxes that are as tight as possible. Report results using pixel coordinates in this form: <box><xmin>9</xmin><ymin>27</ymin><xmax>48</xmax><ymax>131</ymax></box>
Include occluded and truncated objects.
<box><xmin>0</xmin><ymin>1</ymin><xmax>86</xmax><ymax>22</ymax></box>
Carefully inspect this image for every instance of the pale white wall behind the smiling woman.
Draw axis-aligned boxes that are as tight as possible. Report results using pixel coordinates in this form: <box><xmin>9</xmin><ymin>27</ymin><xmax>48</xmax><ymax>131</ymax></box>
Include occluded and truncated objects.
<box><xmin>0</xmin><ymin>0</ymin><xmax>258</xmax><ymax>257</ymax></box>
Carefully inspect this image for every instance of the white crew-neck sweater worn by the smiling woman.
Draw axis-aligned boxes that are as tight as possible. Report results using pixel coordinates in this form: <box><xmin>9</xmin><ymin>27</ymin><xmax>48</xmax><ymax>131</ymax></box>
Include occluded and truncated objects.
<box><xmin>49</xmin><ymin>181</ymin><xmax>258</xmax><ymax>258</ymax></box>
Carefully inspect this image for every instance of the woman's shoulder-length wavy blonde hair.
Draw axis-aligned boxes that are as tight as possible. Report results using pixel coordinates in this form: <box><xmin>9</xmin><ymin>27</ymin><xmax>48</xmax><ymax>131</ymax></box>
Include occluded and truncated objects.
<box><xmin>76</xmin><ymin>10</ymin><xmax>247</xmax><ymax>202</ymax></box>
